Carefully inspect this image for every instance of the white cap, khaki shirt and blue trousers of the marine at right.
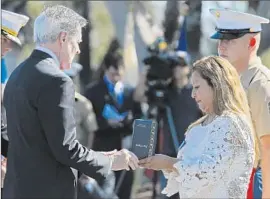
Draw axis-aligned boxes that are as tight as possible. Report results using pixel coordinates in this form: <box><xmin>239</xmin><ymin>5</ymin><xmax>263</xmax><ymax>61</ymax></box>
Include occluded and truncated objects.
<box><xmin>210</xmin><ymin>9</ymin><xmax>270</xmax><ymax>198</ymax></box>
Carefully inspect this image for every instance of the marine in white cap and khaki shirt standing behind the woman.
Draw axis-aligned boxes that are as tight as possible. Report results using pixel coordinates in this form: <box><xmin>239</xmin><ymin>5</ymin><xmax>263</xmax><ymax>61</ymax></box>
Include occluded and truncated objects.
<box><xmin>210</xmin><ymin>9</ymin><xmax>270</xmax><ymax>198</ymax></box>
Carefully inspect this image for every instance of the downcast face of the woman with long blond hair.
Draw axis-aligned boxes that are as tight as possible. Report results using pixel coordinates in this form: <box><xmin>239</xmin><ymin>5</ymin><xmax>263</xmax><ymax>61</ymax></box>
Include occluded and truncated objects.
<box><xmin>191</xmin><ymin>71</ymin><xmax>214</xmax><ymax>114</ymax></box>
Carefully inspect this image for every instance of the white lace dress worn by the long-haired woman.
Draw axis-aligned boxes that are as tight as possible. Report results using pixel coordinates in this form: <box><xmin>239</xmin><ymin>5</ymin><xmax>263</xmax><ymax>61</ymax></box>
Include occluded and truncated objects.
<box><xmin>162</xmin><ymin>113</ymin><xmax>255</xmax><ymax>199</ymax></box>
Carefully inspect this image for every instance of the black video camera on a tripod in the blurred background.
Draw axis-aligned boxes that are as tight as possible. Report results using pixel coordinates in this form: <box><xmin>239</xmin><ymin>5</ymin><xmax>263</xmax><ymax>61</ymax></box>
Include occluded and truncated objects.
<box><xmin>143</xmin><ymin>38</ymin><xmax>186</xmax><ymax>107</ymax></box>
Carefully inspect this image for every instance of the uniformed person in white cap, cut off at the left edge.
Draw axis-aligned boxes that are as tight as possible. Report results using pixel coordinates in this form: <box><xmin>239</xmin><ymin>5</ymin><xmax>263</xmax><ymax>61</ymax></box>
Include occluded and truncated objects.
<box><xmin>1</xmin><ymin>10</ymin><xmax>29</xmax><ymax>193</ymax></box>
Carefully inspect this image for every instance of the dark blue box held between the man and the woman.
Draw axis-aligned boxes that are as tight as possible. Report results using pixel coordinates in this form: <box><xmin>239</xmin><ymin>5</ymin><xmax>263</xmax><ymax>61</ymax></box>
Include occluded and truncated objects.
<box><xmin>131</xmin><ymin>119</ymin><xmax>158</xmax><ymax>160</ymax></box>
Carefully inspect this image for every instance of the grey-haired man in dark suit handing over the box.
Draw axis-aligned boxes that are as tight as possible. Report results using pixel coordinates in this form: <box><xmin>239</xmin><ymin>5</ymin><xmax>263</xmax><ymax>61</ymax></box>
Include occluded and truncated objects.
<box><xmin>3</xmin><ymin>6</ymin><xmax>138</xmax><ymax>199</ymax></box>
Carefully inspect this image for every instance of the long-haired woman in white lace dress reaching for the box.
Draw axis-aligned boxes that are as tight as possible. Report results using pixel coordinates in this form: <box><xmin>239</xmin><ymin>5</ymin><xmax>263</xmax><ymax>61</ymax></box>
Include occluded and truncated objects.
<box><xmin>140</xmin><ymin>56</ymin><xmax>256</xmax><ymax>198</ymax></box>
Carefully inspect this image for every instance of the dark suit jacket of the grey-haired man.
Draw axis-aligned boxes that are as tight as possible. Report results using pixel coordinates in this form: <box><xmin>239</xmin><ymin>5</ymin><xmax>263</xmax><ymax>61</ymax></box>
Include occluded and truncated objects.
<box><xmin>3</xmin><ymin>50</ymin><xmax>111</xmax><ymax>199</ymax></box>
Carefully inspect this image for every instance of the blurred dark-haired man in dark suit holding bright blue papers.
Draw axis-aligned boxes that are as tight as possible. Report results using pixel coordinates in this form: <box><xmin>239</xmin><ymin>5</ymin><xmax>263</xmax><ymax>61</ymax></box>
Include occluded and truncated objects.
<box><xmin>85</xmin><ymin>52</ymin><xmax>142</xmax><ymax>199</ymax></box>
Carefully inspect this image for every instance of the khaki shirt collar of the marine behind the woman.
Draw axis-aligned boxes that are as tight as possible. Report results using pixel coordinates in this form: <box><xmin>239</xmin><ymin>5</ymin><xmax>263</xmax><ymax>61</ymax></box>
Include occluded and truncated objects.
<box><xmin>240</xmin><ymin>57</ymin><xmax>262</xmax><ymax>90</ymax></box>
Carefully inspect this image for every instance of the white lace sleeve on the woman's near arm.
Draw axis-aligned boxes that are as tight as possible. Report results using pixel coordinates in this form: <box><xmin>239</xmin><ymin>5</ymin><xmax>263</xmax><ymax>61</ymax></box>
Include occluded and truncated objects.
<box><xmin>163</xmin><ymin>118</ymin><xmax>253</xmax><ymax>198</ymax></box>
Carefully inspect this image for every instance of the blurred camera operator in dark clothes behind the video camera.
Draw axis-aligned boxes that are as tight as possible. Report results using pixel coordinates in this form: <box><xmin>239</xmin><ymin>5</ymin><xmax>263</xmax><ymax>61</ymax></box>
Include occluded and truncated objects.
<box><xmin>138</xmin><ymin>56</ymin><xmax>202</xmax><ymax>198</ymax></box>
